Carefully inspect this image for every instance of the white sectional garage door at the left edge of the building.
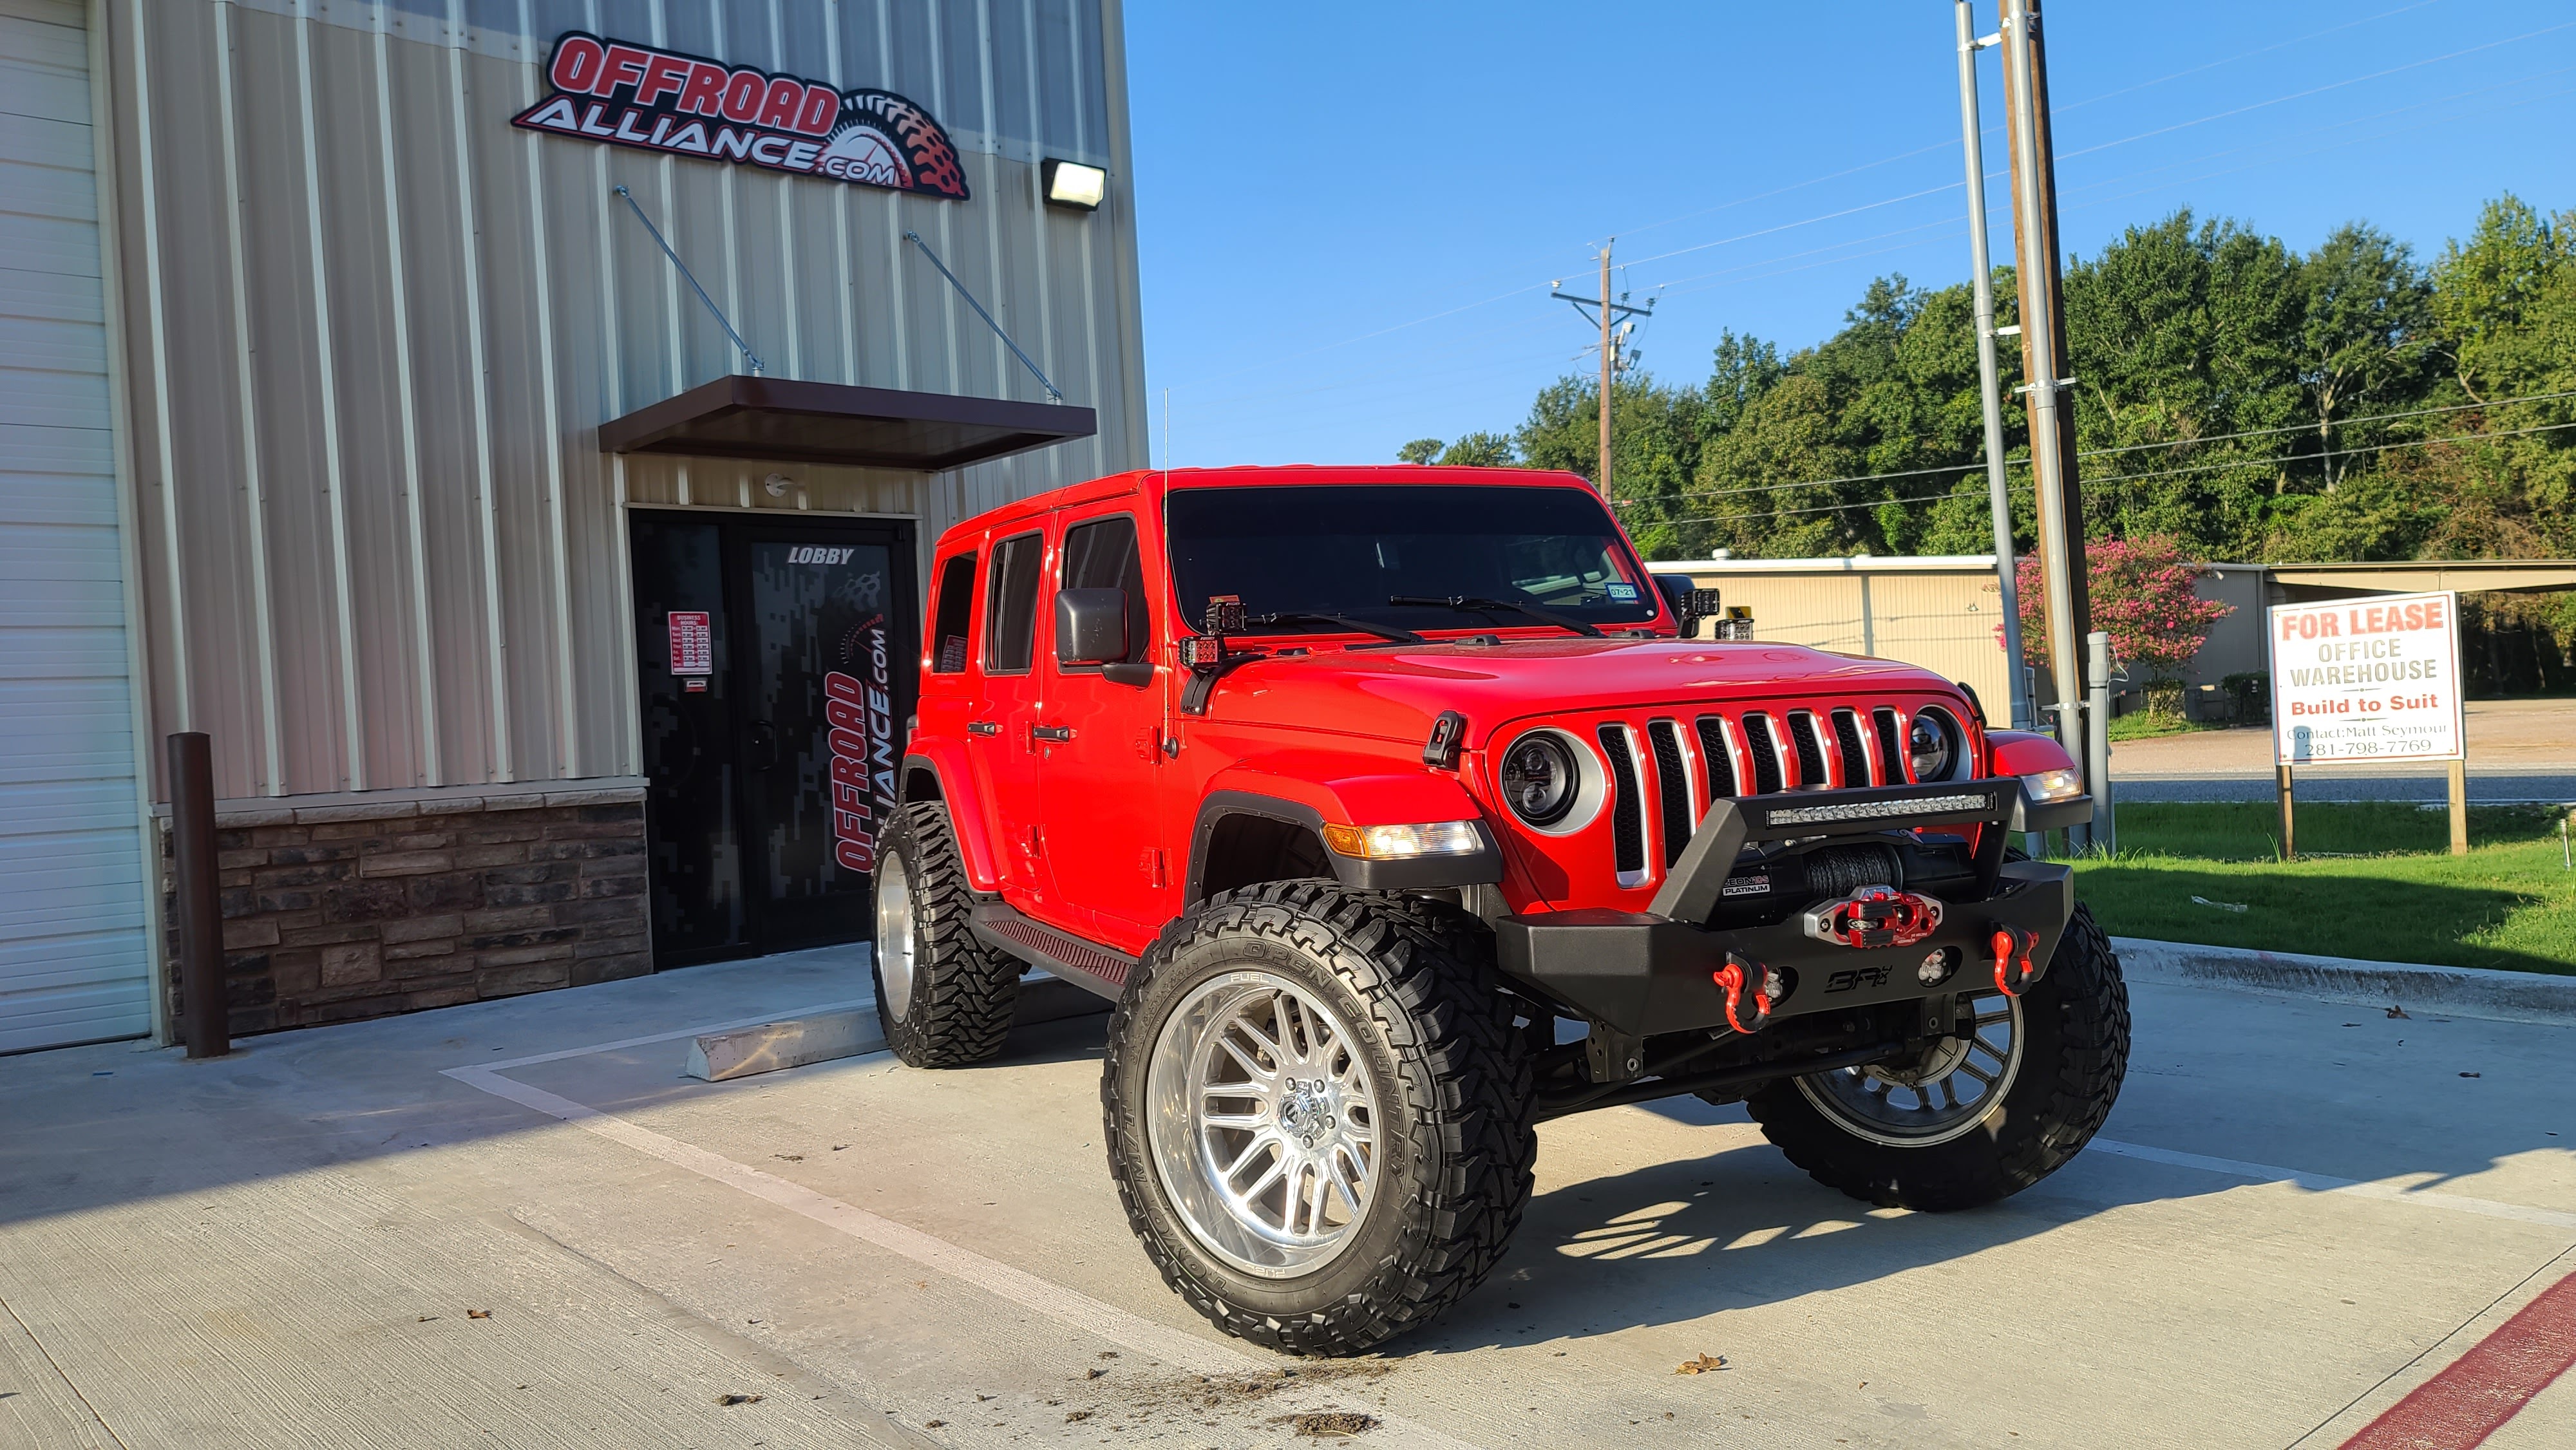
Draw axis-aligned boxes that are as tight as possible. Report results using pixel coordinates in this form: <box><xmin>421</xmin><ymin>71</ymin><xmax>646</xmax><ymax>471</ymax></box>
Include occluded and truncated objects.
<box><xmin>0</xmin><ymin>0</ymin><xmax>152</xmax><ymax>1053</ymax></box>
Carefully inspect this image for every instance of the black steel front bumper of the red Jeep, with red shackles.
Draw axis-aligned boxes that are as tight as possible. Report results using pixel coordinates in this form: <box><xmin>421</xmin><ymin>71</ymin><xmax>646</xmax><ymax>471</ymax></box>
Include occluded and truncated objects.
<box><xmin>1494</xmin><ymin>780</ymin><xmax>2089</xmax><ymax>1038</ymax></box>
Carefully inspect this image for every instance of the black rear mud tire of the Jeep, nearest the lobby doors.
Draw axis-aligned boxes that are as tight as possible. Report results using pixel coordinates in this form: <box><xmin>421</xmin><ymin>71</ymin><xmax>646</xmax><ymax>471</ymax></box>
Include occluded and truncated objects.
<box><xmin>868</xmin><ymin>801</ymin><xmax>1023</xmax><ymax>1066</ymax></box>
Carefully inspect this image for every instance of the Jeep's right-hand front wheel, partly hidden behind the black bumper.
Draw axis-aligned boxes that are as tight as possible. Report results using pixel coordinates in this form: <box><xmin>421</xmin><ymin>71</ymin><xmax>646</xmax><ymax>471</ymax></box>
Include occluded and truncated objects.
<box><xmin>1744</xmin><ymin>904</ymin><xmax>2128</xmax><ymax>1210</ymax></box>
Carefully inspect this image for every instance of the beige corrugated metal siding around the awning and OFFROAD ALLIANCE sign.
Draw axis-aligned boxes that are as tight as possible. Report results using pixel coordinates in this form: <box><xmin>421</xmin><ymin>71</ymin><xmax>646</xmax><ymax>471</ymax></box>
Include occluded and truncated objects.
<box><xmin>106</xmin><ymin>0</ymin><xmax>1144</xmax><ymax>798</ymax></box>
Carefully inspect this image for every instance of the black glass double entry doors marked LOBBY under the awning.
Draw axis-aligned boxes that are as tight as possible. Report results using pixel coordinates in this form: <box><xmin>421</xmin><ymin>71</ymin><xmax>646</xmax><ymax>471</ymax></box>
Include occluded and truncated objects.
<box><xmin>634</xmin><ymin>510</ymin><xmax>920</xmax><ymax>966</ymax></box>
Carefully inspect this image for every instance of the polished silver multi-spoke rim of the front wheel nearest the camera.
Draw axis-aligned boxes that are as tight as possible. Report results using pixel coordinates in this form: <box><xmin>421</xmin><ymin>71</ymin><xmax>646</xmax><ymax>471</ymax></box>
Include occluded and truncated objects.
<box><xmin>1144</xmin><ymin>971</ymin><xmax>1378</xmax><ymax>1277</ymax></box>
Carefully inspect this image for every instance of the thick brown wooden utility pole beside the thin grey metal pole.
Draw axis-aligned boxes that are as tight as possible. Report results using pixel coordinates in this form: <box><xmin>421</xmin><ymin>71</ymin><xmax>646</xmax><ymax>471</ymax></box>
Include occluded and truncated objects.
<box><xmin>1999</xmin><ymin>0</ymin><xmax>2110</xmax><ymax>845</ymax></box>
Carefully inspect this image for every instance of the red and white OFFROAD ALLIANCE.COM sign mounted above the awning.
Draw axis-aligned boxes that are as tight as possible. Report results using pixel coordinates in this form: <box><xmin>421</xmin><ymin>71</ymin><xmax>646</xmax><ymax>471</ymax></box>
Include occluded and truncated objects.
<box><xmin>510</xmin><ymin>31</ymin><xmax>966</xmax><ymax>201</ymax></box>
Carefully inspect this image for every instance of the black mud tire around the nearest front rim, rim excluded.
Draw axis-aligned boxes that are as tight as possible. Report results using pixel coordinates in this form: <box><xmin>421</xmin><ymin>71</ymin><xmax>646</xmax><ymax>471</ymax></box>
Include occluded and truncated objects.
<box><xmin>1100</xmin><ymin>881</ymin><xmax>1538</xmax><ymax>1355</ymax></box>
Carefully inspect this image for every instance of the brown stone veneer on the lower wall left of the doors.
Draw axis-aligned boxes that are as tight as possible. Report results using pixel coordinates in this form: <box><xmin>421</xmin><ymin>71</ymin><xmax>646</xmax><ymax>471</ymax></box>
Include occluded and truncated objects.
<box><xmin>162</xmin><ymin>788</ymin><xmax>652</xmax><ymax>1035</ymax></box>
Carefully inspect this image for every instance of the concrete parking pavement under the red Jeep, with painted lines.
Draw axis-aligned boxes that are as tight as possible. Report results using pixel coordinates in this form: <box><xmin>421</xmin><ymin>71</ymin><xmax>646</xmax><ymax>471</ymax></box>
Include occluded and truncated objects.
<box><xmin>0</xmin><ymin>953</ymin><xmax>2576</xmax><ymax>1450</ymax></box>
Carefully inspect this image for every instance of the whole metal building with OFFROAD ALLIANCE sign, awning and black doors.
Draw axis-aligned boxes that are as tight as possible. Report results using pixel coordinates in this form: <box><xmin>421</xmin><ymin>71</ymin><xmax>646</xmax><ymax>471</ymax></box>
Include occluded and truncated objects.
<box><xmin>0</xmin><ymin>0</ymin><xmax>1146</xmax><ymax>1051</ymax></box>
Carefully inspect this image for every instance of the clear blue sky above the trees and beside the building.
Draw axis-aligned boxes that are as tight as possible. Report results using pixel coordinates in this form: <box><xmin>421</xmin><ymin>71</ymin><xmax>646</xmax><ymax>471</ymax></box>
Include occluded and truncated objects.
<box><xmin>1126</xmin><ymin>0</ymin><xmax>2576</xmax><ymax>466</ymax></box>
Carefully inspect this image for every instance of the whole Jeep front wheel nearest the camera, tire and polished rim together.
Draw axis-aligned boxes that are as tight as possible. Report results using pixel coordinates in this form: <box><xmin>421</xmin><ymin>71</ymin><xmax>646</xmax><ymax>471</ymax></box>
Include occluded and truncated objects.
<box><xmin>1100</xmin><ymin>881</ymin><xmax>1538</xmax><ymax>1355</ymax></box>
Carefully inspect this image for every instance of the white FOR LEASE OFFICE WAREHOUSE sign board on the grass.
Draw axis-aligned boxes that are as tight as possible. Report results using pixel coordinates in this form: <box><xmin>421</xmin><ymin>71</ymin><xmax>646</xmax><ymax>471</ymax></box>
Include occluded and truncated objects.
<box><xmin>2272</xmin><ymin>592</ymin><xmax>2465</xmax><ymax>765</ymax></box>
